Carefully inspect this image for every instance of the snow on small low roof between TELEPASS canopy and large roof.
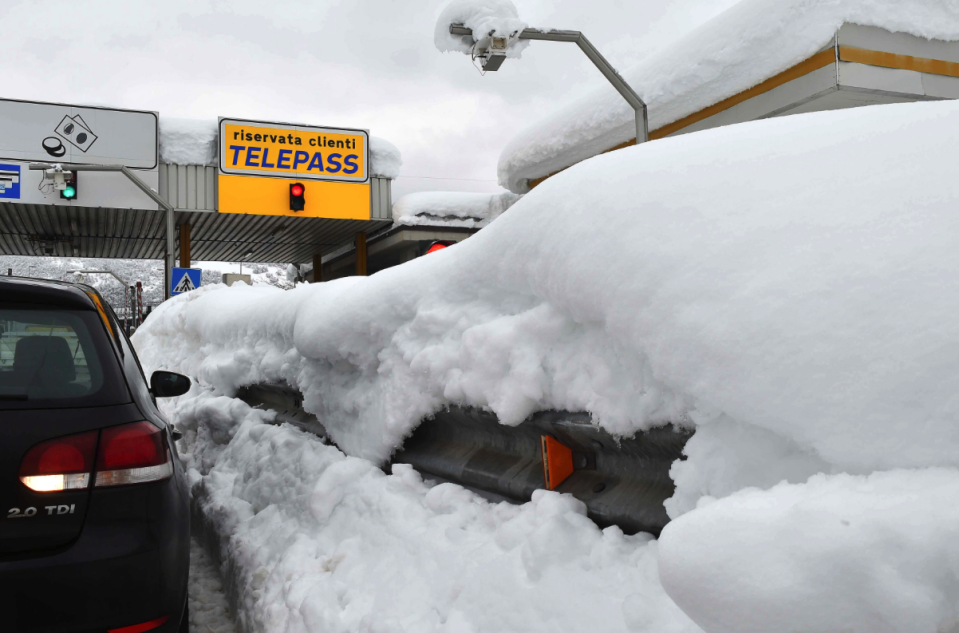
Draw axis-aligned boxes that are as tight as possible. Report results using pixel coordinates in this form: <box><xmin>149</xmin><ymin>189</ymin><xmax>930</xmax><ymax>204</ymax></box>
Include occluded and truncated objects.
<box><xmin>393</xmin><ymin>191</ymin><xmax>522</xmax><ymax>228</ymax></box>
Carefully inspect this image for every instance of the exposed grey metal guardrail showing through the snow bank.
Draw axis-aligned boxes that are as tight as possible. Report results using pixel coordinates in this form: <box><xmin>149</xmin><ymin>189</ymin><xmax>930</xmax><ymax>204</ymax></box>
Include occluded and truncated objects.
<box><xmin>238</xmin><ymin>385</ymin><xmax>692</xmax><ymax>535</ymax></box>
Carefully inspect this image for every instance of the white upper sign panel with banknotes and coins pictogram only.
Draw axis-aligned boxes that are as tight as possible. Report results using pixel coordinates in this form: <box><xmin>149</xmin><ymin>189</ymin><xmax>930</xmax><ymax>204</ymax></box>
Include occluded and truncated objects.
<box><xmin>0</xmin><ymin>99</ymin><xmax>158</xmax><ymax>169</ymax></box>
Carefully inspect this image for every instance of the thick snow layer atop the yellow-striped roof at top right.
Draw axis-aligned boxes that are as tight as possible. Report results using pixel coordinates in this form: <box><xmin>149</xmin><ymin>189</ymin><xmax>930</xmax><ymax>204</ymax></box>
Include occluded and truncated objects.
<box><xmin>498</xmin><ymin>0</ymin><xmax>959</xmax><ymax>193</ymax></box>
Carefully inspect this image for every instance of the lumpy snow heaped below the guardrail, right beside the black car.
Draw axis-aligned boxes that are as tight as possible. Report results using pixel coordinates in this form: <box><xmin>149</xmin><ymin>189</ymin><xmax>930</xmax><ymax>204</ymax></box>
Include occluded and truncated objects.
<box><xmin>173</xmin><ymin>393</ymin><xmax>699</xmax><ymax>633</ymax></box>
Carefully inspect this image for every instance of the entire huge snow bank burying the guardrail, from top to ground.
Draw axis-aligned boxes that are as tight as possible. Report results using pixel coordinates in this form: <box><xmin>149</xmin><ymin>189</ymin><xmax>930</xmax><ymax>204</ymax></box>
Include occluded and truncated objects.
<box><xmin>136</xmin><ymin>97</ymin><xmax>959</xmax><ymax>631</ymax></box>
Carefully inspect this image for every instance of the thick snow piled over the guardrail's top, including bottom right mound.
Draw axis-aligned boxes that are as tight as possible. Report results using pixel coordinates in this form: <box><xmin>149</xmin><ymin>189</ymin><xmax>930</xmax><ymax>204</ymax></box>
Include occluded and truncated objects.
<box><xmin>136</xmin><ymin>102</ymin><xmax>959</xmax><ymax>631</ymax></box>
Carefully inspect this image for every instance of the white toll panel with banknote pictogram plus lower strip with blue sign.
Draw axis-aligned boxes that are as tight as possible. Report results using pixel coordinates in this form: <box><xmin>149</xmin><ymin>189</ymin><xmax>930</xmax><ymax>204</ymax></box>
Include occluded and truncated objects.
<box><xmin>0</xmin><ymin>99</ymin><xmax>159</xmax><ymax>210</ymax></box>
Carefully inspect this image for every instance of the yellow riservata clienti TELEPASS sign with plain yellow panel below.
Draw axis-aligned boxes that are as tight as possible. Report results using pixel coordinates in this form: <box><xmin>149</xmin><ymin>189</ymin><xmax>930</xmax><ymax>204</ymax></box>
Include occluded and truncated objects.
<box><xmin>217</xmin><ymin>118</ymin><xmax>371</xmax><ymax>220</ymax></box>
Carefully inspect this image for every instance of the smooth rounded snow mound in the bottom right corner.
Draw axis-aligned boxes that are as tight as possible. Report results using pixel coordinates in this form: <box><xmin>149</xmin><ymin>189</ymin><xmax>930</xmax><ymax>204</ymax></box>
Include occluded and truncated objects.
<box><xmin>659</xmin><ymin>469</ymin><xmax>959</xmax><ymax>633</ymax></box>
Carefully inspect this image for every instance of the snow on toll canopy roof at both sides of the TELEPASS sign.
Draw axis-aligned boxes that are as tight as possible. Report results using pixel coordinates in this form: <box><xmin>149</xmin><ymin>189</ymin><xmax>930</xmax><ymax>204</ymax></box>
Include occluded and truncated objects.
<box><xmin>160</xmin><ymin>117</ymin><xmax>403</xmax><ymax>179</ymax></box>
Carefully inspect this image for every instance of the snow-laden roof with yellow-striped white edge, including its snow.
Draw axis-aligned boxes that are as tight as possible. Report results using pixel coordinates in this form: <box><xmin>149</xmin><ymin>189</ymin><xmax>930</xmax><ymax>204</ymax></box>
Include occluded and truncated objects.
<box><xmin>499</xmin><ymin>0</ymin><xmax>959</xmax><ymax>193</ymax></box>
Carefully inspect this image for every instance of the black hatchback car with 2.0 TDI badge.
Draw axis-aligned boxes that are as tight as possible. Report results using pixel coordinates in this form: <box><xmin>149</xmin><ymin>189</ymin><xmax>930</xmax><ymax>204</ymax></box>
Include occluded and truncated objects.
<box><xmin>0</xmin><ymin>277</ymin><xmax>190</xmax><ymax>633</ymax></box>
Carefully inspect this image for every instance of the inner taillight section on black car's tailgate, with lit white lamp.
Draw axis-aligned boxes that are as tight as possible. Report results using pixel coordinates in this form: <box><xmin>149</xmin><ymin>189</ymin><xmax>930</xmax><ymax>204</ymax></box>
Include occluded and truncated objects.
<box><xmin>20</xmin><ymin>431</ymin><xmax>97</xmax><ymax>492</ymax></box>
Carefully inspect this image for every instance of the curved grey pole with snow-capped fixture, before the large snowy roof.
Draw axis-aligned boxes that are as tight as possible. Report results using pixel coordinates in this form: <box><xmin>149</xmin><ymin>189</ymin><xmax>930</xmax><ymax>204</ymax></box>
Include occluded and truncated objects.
<box><xmin>433</xmin><ymin>0</ymin><xmax>649</xmax><ymax>144</ymax></box>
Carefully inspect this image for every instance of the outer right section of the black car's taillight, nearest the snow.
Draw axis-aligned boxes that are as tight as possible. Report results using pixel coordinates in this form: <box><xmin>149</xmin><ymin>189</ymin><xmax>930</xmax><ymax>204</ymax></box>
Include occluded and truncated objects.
<box><xmin>93</xmin><ymin>422</ymin><xmax>173</xmax><ymax>486</ymax></box>
